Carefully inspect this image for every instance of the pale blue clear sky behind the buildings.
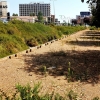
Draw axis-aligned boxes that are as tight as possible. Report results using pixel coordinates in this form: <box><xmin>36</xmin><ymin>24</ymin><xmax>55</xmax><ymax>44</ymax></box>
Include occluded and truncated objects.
<box><xmin>6</xmin><ymin>0</ymin><xmax>89</xmax><ymax>22</ymax></box>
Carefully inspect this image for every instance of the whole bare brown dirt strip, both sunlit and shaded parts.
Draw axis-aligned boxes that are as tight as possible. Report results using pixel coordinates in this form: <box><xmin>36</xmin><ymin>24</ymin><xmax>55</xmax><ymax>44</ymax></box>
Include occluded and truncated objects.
<box><xmin>0</xmin><ymin>30</ymin><xmax>100</xmax><ymax>100</ymax></box>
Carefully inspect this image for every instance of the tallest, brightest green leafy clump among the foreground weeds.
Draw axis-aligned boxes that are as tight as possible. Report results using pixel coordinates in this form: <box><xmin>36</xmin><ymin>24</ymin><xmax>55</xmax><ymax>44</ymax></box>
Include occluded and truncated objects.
<box><xmin>16</xmin><ymin>83</ymin><xmax>41</xmax><ymax>100</ymax></box>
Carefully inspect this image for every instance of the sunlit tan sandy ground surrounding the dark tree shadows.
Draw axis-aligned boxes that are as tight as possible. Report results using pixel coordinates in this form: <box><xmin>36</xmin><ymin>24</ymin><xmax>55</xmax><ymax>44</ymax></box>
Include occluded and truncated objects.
<box><xmin>0</xmin><ymin>30</ymin><xmax>100</xmax><ymax>100</ymax></box>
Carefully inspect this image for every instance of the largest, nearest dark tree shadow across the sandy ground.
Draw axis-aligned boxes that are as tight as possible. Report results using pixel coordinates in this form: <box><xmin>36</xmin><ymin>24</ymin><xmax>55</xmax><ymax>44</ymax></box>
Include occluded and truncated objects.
<box><xmin>24</xmin><ymin>50</ymin><xmax>100</xmax><ymax>83</ymax></box>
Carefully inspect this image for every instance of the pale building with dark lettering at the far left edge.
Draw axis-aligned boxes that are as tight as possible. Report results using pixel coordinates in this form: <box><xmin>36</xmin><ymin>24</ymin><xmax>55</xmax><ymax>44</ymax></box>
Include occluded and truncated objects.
<box><xmin>0</xmin><ymin>1</ymin><xmax>8</xmax><ymax>17</ymax></box>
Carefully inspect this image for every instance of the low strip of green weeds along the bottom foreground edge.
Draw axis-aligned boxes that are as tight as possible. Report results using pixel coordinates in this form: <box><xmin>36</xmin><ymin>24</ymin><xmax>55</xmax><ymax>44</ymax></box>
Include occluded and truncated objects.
<box><xmin>0</xmin><ymin>82</ymin><xmax>99</xmax><ymax>100</ymax></box>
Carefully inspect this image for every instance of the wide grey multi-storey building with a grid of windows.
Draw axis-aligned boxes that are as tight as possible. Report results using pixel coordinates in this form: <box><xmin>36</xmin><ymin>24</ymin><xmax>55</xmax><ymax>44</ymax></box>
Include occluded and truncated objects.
<box><xmin>19</xmin><ymin>3</ymin><xmax>50</xmax><ymax>17</ymax></box>
